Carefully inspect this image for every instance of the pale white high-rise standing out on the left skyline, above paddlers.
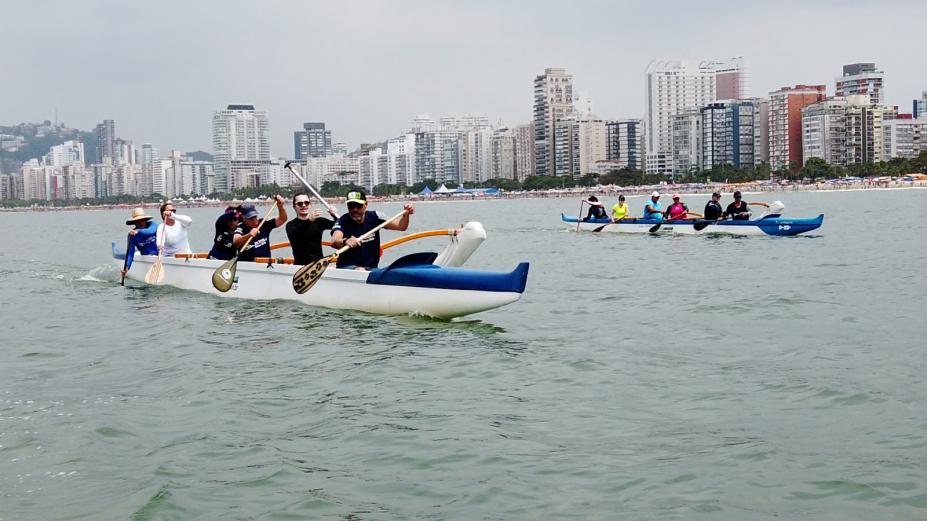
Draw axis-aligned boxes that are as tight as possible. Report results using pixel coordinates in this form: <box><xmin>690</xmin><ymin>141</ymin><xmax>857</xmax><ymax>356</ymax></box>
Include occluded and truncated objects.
<box><xmin>212</xmin><ymin>105</ymin><xmax>270</xmax><ymax>192</ymax></box>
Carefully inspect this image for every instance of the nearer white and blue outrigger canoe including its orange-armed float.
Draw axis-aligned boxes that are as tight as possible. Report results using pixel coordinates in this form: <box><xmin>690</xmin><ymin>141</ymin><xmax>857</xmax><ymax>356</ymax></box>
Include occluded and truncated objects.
<box><xmin>112</xmin><ymin>222</ymin><xmax>528</xmax><ymax>319</ymax></box>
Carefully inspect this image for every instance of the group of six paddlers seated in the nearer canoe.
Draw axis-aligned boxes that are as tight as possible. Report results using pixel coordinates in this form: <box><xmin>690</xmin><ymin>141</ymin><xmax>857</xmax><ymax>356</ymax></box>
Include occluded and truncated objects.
<box><xmin>122</xmin><ymin>190</ymin><xmax>415</xmax><ymax>276</ymax></box>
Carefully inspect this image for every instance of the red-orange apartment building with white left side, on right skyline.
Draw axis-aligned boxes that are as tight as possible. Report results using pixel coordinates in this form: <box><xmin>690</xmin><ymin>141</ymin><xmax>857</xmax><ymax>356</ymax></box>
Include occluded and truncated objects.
<box><xmin>769</xmin><ymin>85</ymin><xmax>827</xmax><ymax>171</ymax></box>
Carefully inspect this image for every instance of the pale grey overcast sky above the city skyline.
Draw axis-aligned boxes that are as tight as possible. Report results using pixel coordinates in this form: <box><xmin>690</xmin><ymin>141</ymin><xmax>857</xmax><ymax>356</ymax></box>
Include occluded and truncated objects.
<box><xmin>0</xmin><ymin>0</ymin><xmax>927</xmax><ymax>157</ymax></box>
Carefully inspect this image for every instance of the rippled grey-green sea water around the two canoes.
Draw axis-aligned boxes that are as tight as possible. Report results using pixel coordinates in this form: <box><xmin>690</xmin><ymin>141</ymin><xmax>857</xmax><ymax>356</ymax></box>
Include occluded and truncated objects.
<box><xmin>0</xmin><ymin>190</ymin><xmax>927</xmax><ymax>521</ymax></box>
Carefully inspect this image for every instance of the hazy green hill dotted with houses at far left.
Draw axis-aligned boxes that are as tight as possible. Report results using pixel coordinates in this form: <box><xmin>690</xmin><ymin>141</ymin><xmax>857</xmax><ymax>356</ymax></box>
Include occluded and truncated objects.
<box><xmin>0</xmin><ymin>120</ymin><xmax>97</xmax><ymax>174</ymax></box>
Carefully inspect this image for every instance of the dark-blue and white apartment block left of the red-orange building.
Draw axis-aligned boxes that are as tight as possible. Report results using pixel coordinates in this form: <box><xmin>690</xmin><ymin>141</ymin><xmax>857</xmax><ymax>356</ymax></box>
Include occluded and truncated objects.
<box><xmin>701</xmin><ymin>99</ymin><xmax>768</xmax><ymax>169</ymax></box>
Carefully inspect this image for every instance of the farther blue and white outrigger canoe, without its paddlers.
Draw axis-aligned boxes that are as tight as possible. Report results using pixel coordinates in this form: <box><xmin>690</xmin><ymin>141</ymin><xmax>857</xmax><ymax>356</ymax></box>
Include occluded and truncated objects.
<box><xmin>560</xmin><ymin>201</ymin><xmax>824</xmax><ymax>236</ymax></box>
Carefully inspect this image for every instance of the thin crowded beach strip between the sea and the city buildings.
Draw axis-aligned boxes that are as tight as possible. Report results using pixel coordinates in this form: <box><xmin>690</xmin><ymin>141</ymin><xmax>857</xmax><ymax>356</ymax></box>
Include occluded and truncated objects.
<box><xmin>0</xmin><ymin>181</ymin><xmax>927</xmax><ymax>213</ymax></box>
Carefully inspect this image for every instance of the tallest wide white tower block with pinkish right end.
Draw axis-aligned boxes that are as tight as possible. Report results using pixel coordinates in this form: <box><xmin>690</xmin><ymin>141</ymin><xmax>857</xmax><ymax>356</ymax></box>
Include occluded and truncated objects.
<box><xmin>646</xmin><ymin>58</ymin><xmax>752</xmax><ymax>172</ymax></box>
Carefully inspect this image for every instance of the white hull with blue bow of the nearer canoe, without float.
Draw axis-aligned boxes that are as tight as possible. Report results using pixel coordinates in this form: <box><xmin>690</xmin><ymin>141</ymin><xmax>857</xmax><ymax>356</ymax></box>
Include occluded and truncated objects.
<box><xmin>113</xmin><ymin>244</ymin><xmax>528</xmax><ymax>319</ymax></box>
